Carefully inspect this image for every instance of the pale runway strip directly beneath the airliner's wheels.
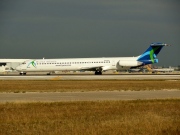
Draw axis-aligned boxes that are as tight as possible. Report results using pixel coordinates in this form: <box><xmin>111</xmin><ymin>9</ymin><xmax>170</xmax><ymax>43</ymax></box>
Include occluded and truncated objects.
<box><xmin>0</xmin><ymin>74</ymin><xmax>180</xmax><ymax>80</ymax></box>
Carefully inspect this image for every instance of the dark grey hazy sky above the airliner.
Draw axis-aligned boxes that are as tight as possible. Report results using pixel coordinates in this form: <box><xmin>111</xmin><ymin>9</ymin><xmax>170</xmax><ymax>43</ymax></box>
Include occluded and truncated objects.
<box><xmin>0</xmin><ymin>0</ymin><xmax>180</xmax><ymax>66</ymax></box>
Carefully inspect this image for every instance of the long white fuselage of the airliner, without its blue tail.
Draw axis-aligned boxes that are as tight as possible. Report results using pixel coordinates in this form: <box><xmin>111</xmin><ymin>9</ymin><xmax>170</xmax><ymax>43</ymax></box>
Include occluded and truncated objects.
<box><xmin>16</xmin><ymin>57</ymin><xmax>142</xmax><ymax>72</ymax></box>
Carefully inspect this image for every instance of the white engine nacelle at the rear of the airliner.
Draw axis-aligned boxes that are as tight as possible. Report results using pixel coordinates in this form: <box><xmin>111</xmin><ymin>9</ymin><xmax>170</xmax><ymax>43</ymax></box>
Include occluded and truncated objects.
<box><xmin>119</xmin><ymin>60</ymin><xmax>142</xmax><ymax>67</ymax></box>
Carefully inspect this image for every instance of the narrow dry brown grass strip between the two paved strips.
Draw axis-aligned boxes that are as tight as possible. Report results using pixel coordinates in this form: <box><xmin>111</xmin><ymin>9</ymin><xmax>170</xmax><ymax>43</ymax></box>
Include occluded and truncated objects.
<box><xmin>0</xmin><ymin>80</ymin><xmax>180</xmax><ymax>93</ymax></box>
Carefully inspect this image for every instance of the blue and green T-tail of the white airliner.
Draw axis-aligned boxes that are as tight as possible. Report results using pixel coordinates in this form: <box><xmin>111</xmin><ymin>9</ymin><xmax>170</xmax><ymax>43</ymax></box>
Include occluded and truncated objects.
<box><xmin>137</xmin><ymin>43</ymin><xmax>168</xmax><ymax>65</ymax></box>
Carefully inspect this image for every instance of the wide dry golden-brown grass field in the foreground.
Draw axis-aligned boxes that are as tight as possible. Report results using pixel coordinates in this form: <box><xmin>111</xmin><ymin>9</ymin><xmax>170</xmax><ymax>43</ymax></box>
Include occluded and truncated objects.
<box><xmin>0</xmin><ymin>99</ymin><xmax>180</xmax><ymax>135</ymax></box>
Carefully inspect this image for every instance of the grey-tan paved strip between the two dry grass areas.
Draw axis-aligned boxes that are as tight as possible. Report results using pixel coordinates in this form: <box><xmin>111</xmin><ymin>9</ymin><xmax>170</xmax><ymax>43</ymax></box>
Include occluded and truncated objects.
<box><xmin>0</xmin><ymin>90</ymin><xmax>180</xmax><ymax>103</ymax></box>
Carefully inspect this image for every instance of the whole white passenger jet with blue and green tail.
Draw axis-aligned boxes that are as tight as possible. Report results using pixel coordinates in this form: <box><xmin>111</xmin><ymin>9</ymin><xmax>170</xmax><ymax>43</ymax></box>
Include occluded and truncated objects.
<box><xmin>16</xmin><ymin>43</ymin><xmax>168</xmax><ymax>75</ymax></box>
